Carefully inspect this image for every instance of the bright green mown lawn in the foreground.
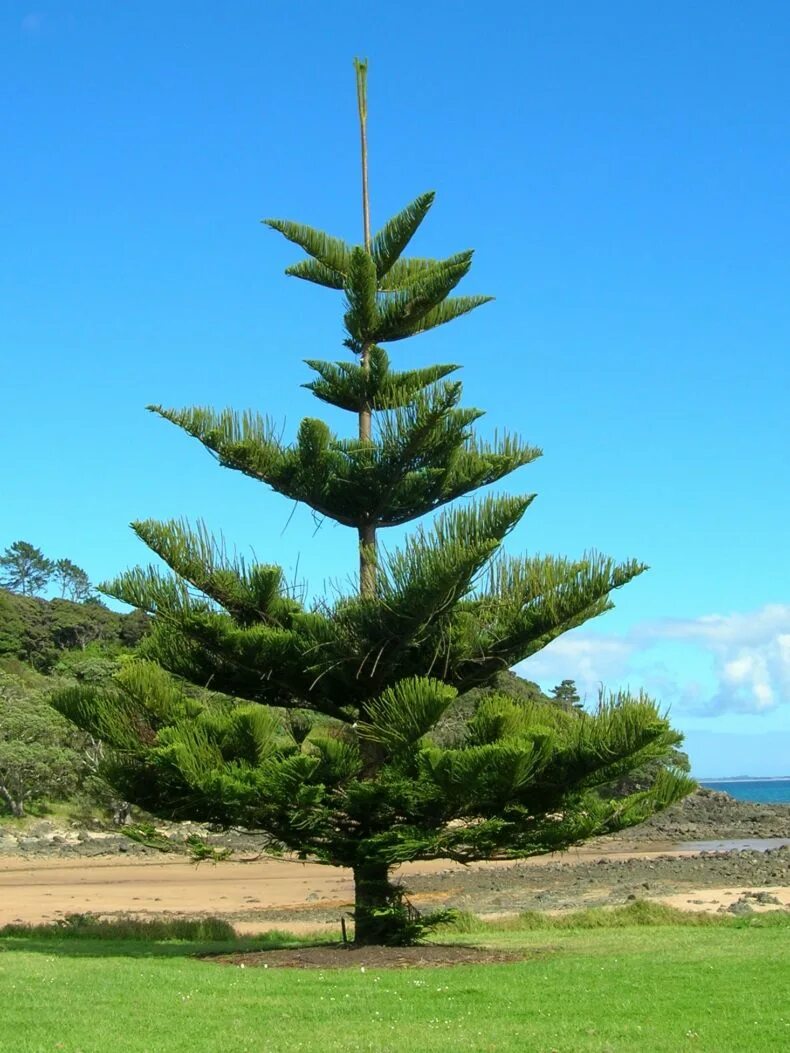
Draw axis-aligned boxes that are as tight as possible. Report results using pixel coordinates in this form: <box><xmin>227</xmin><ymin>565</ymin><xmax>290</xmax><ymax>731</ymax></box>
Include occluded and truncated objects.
<box><xmin>0</xmin><ymin>912</ymin><xmax>790</xmax><ymax>1053</ymax></box>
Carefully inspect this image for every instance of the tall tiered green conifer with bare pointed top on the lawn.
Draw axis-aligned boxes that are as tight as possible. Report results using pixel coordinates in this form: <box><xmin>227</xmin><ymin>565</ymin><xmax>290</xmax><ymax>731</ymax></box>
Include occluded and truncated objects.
<box><xmin>55</xmin><ymin>63</ymin><xmax>692</xmax><ymax>943</ymax></box>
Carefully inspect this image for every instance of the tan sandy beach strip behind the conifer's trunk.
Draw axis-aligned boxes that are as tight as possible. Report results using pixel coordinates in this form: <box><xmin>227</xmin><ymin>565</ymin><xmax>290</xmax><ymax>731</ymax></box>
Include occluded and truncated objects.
<box><xmin>0</xmin><ymin>848</ymin><xmax>790</xmax><ymax>932</ymax></box>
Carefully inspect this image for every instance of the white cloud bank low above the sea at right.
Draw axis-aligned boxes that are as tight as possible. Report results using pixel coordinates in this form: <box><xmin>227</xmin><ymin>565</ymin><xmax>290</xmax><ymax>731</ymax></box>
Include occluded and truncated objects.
<box><xmin>519</xmin><ymin>603</ymin><xmax>790</xmax><ymax>717</ymax></box>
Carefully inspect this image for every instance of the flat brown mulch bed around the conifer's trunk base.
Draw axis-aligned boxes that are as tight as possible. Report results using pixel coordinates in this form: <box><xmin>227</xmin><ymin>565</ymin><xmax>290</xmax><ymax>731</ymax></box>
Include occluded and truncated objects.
<box><xmin>200</xmin><ymin>943</ymin><xmax>555</xmax><ymax>969</ymax></box>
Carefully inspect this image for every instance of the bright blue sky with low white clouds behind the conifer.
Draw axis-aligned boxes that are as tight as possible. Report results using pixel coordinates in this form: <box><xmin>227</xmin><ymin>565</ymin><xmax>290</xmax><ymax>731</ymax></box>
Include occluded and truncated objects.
<box><xmin>0</xmin><ymin>0</ymin><xmax>790</xmax><ymax>777</ymax></box>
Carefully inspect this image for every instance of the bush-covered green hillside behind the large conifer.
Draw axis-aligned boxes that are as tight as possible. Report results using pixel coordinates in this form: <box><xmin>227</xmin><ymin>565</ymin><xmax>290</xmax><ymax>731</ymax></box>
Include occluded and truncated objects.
<box><xmin>0</xmin><ymin>589</ymin><xmax>689</xmax><ymax>822</ymax></box>
